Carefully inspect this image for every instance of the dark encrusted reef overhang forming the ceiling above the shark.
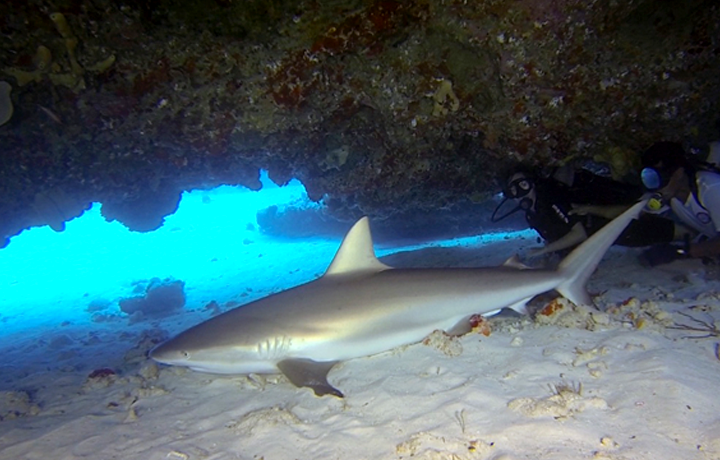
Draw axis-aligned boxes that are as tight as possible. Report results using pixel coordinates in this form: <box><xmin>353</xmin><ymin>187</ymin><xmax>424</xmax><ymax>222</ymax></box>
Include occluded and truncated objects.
<box><xmin>0</xmin><ymin>0</ymin><xmax>720</xmax><ymax>237</ymax></box>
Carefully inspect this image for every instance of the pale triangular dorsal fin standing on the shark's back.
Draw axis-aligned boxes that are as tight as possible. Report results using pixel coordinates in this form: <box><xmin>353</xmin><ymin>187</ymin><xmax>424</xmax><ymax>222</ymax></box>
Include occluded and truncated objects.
<box><xmin>325</xmin><ymin>217</ymin><xmax>390</xmax><ymax>276</ymax></box>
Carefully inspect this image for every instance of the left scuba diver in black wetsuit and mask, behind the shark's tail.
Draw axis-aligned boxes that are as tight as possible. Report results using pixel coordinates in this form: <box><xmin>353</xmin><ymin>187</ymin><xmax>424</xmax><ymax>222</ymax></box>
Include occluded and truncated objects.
<box><xmin>491</xmin><ymin>166</ymin><xmax>687</xmax><ymax>257</ymax></box>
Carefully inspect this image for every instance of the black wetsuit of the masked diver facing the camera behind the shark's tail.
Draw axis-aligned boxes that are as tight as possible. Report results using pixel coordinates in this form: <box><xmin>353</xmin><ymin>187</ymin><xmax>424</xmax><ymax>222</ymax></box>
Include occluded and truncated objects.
<box><xmin>525</xmin><ymin>176</ymin><xmax>675</xmax><ymax>247</ymax></box>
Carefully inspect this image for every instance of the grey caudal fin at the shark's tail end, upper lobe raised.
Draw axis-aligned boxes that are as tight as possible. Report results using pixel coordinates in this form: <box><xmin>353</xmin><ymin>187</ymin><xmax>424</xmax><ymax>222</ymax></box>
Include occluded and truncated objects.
<box><xmin>556</xmin><ymin>200</ymin><xmax>647</xmax><ymax>305</ymax></box>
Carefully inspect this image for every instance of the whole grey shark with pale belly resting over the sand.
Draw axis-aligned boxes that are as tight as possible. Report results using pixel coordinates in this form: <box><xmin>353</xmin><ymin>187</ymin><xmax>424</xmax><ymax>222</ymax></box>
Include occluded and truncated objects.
<box><xmin>149</xmin><ymin>201</ymin><xmax>646</xmax><ymax>398</ymax></box>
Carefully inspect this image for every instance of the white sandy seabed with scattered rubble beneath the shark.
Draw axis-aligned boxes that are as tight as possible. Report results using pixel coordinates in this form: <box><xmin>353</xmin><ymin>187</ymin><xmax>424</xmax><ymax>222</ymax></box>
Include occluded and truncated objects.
<box><xmin>0</xmin><ymin>237</ymin><xmax>720</xmax><ymax>460</ymax></box>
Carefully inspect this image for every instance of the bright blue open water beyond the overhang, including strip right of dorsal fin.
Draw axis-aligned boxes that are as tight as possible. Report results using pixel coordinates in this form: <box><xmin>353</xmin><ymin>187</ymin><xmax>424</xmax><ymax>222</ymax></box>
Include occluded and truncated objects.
<box><xmin>0</xmin><ymin>174</ymin><xmax>524</xmax><ymax>384</ymax></box>
